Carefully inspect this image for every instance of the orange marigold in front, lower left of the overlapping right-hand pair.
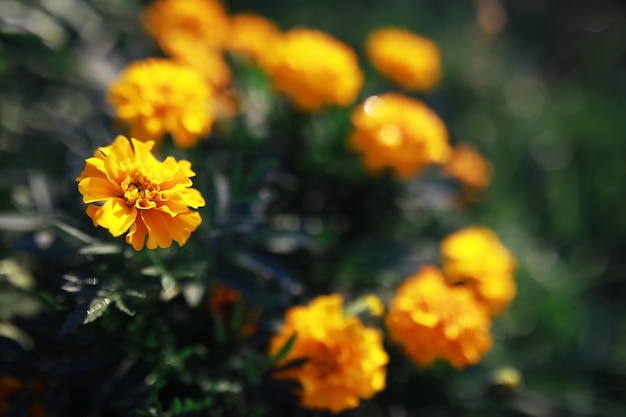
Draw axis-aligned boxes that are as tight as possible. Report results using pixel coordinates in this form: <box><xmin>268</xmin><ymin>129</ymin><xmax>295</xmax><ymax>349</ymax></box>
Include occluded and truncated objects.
<box><xmin>385</xmin><ymin>266</ymin><xmax>492</xmax><ymax>369</ymax></box>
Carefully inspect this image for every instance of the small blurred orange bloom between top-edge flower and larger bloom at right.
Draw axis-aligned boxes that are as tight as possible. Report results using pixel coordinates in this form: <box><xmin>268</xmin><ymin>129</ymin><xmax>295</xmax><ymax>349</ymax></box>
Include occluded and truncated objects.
<box><xmin>226</xmin><ymin>13</ymin><xmax>281</xmax><ymax>62</ymax></box>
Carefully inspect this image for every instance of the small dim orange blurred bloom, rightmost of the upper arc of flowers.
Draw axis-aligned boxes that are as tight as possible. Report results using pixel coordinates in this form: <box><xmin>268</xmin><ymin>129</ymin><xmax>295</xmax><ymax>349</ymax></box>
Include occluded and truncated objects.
<box><xmin>443</xmin><ymin>145</ymin><xmax>491</xmax><ymax>189</ymax></box>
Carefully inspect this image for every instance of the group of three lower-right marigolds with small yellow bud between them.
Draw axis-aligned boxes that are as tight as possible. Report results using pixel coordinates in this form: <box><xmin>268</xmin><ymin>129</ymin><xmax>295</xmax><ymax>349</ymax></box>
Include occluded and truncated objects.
<box><xmin>270</xmin><ymin>227</ymin><xmax>515</xmax><ymax>413</ymax></box>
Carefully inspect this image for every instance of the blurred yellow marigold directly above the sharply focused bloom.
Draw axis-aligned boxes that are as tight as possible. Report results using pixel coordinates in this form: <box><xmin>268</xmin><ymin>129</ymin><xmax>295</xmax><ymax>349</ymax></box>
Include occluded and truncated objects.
<box><xmin>107</xmin><ymin>58</ymin><xmax>213</xmax><ymax>148</ymax></box>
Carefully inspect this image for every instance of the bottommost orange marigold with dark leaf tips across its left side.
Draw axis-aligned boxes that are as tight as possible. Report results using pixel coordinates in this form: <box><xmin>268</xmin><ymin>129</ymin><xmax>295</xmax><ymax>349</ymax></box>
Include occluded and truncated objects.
<box><xmin>270</xmin><ymin>295</ymin><xmax>389</xmax><ymax>413</ymax></box>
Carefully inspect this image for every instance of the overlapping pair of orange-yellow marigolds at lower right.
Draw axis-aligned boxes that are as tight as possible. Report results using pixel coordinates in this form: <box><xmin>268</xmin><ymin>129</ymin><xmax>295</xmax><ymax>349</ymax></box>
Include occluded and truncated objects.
<box><xmin>386</xmin><ymin>227</ymin><xmax>516</xmax><ymax>368</ymax></box>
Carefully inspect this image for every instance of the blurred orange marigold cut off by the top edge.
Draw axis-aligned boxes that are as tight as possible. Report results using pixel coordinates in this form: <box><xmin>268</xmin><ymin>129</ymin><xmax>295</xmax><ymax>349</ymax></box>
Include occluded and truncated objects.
<box><xmin>143</xmin><ymin>0</ymin><xmax>228</xmax><ymax>58</ymax></box>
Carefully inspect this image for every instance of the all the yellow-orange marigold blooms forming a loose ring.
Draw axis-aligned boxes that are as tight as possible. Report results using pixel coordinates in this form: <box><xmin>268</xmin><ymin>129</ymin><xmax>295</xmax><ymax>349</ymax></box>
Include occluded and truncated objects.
<box><xmin>77</xmin><ymin>0</ymin><xmax>516</xmax><ymax>413</ymax></box>
